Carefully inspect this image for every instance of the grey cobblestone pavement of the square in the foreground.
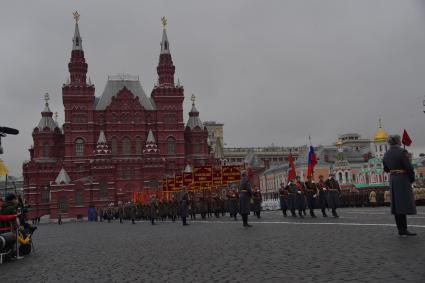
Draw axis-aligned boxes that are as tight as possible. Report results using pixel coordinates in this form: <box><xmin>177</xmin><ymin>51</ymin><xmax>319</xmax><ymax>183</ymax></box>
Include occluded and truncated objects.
<box><xmin>0</xmin><ymin>207</ymin><xmax>425</xmax><ymax>283</ymax></box>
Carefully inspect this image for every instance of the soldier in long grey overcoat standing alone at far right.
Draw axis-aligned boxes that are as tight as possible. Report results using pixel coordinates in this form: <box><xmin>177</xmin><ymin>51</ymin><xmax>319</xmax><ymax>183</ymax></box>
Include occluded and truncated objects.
<box><xmin>383</xmin><ymin>135</ymin><xmax>416</xmax><ymax>236</ymax></box>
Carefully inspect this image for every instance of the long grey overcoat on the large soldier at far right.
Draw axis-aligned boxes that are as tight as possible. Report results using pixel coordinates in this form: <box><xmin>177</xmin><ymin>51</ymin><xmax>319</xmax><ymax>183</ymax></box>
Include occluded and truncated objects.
<box><xmin>383</xmin><ymin>146</ymin><xmax>416</xmax><ymax>214</ymax></box>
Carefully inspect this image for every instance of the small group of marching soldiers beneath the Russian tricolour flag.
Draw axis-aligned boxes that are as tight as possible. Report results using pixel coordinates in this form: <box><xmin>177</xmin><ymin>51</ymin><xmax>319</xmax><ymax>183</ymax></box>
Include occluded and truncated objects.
<box><xmin>279</xmin><ymin>174</ymin><xmax>341</xmax><ymax>218</ymax></box>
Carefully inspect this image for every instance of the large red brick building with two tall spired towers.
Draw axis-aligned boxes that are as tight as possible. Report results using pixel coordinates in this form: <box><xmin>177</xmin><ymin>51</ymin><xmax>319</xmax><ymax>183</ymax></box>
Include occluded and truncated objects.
<box><xmin>23</xmin><ymin>18</ymin><xmax>213</xmax><ymax>221</ymax></box>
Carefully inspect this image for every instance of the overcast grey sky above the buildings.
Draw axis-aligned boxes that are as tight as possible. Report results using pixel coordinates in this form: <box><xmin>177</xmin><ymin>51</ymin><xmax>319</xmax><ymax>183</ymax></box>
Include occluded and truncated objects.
<box><xmin>0</xmin><ymin>0</ymin><xmax>425</xmax><ymax>175</ymax></box>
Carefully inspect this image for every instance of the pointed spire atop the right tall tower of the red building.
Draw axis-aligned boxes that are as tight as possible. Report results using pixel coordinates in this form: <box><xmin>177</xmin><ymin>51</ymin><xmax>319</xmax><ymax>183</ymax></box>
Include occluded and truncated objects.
<box><xmin>156</xmin><ymin>17</ymin><xmax>175</xmax><ymax>86</ymax></box>
